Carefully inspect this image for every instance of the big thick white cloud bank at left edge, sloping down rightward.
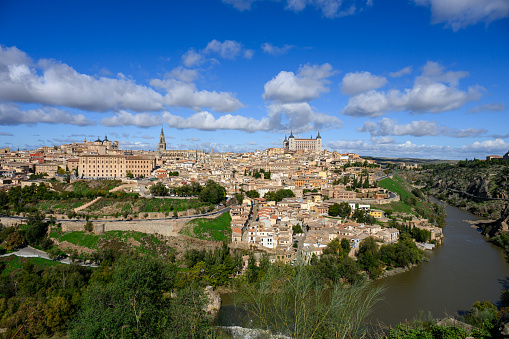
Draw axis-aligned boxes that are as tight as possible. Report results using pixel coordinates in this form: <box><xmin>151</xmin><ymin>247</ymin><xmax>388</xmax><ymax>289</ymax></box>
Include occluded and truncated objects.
<box><xmin>0</xmin><ymin>46</ymin><xmax>162</xmax><ymax>111</ymax></box>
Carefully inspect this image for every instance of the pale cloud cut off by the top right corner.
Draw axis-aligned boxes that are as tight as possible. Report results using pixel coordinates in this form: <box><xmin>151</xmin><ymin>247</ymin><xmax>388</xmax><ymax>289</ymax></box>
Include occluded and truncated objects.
<box><xmin>414</xmin><ymin>0</ymin><xmax>509</xmax><ymax>31</ymax></box>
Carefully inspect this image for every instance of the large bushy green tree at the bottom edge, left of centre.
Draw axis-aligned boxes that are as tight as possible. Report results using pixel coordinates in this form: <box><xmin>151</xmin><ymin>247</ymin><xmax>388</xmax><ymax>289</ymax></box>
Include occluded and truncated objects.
<box><xmin>70</xmin><ymin>255</ymin><xmax>210</xmax><ymax>338</ymax></box>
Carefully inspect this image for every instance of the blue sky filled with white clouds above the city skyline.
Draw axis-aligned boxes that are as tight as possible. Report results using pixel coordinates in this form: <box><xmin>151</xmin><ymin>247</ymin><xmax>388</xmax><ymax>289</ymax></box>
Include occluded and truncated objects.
<box><xmin>0</xmin><ymin>0</ymin><xmax>509</xmax><ymax>159</ymax></box>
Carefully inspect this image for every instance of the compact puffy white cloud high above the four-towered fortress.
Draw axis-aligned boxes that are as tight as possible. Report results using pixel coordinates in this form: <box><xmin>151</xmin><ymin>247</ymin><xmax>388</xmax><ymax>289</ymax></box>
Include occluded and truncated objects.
<box><xmin>263</xmin><ymin>63</ymin><xmax>336</xmax><ymax>103</ymax></box>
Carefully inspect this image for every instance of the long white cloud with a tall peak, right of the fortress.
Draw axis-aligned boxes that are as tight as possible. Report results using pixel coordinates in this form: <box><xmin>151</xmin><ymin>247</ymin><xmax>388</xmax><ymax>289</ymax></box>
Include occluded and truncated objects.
<box><xmin>343</xmin><ymin>61</ymin><xmax>484</xmax><ymax>117</ymax></box>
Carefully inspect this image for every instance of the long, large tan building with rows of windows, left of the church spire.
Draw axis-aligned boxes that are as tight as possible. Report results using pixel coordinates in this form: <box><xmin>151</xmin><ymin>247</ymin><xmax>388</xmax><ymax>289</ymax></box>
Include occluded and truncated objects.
<box><xmin>78</xmin><ymin>154</ymin><xmax>156</xmax><ymax>179</ymax></box>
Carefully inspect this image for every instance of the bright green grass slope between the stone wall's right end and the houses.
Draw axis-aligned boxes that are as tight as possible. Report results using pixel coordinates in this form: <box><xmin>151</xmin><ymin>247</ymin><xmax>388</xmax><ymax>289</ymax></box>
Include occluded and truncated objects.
<box><xmin>181</xmin><ymin>212</ymin><xmax>232</xmax><ymax>241</ymax></box>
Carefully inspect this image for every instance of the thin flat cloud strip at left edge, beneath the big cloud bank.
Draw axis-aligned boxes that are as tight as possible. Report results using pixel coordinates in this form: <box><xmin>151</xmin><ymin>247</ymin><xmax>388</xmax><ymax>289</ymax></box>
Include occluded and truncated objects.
<box><xmin>0</xmin><ymin>104</ymin><xmax>95</xmax><ymax>126</ymax></box>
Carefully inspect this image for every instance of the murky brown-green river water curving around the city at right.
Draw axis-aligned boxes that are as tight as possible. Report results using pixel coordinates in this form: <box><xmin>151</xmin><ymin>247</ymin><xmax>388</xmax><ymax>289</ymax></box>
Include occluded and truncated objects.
<box><xmin>219</xmin><ymin>205</ymin><xmax>509</xmax><ymax>326</ymax></box>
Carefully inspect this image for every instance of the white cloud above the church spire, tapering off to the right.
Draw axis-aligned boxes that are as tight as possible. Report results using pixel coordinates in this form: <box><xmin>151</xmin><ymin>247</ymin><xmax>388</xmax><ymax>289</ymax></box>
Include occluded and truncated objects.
<box><xmin>150</xmin><ymin>79</ymin><xmax>244</xmax><ymax>112</ymax></box>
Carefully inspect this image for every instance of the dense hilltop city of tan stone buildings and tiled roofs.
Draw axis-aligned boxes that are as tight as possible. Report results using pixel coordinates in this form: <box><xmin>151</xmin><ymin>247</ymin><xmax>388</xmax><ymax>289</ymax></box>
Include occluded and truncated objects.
<box><xmin>0</xmin><ymin>129</ymin><xmax>452</xmax><ymax>262</ymax></box>
